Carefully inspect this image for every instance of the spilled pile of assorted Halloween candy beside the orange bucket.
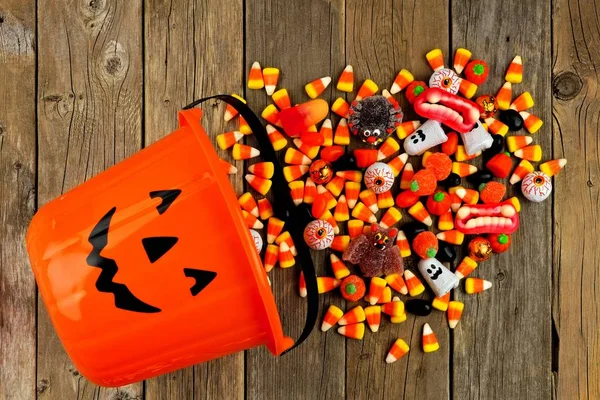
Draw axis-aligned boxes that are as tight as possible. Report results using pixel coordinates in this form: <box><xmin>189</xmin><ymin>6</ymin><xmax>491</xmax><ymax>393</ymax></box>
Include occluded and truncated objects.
<box><xmin>217</xmin><ymin>48</ymin><xmax>566</xmax><ymax>363</ymax></box>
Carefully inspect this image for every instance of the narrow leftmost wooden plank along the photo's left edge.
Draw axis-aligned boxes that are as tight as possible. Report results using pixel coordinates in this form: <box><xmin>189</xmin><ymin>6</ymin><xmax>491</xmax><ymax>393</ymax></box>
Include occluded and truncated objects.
<box><xmin>0</xmin><ymin>0</ymin><xmax>36</xmax><ymax>399</ymax></box>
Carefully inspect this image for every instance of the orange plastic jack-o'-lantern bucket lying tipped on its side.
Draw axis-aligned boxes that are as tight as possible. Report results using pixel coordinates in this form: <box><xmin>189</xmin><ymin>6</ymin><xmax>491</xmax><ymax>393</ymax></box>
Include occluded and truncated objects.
<box><xmin>27</xmin><ymin>96</ymin><xmax>316</xmax><ymax>386</ymax></box>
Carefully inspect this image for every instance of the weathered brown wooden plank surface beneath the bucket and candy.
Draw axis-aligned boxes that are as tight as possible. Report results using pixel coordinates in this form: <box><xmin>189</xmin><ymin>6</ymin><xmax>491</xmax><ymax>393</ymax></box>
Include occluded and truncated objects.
<box><xmin>0</xmin><ymin>0</ymin><xmax>600</xmax><ymax>399</ymax></box>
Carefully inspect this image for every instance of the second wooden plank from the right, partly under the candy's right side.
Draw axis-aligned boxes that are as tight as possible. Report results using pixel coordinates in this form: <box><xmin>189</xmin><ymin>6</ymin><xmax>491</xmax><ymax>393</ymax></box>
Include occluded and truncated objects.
<box><xmin>451</xmin><ymin>0</ymin><xmax>552</xmax><ymax>399</ymax></box>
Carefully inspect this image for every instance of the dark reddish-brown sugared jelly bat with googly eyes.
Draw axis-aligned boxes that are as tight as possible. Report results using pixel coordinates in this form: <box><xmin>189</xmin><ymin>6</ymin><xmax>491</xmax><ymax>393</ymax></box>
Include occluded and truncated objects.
<box><xmin>342</xmin><ymin>225</ymin><xmax>404</xmax><ymax>277</ymax></box>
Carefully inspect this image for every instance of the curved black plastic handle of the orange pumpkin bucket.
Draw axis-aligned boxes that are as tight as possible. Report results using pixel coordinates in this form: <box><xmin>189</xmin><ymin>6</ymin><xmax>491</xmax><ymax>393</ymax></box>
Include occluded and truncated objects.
<box><xmin>183</xmin><ymin>94</ymin><xmax>319</xmax><ymax>355</ymax></box>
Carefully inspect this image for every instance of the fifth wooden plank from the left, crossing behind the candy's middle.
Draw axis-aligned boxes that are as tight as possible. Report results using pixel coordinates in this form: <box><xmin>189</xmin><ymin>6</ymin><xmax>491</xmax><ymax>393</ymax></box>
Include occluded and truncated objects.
<box><xmin>346</xmin><ymin>0</ymin><xmax>450</xmax><ymax>399</ymax></box>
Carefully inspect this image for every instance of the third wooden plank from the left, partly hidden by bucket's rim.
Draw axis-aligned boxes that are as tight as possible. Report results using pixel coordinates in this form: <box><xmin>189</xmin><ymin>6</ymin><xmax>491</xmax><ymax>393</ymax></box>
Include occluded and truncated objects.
<box><xmin>145</xmin><ymin>0</ymin><xmax>244</xmax><ymax>399</ymax></box>
